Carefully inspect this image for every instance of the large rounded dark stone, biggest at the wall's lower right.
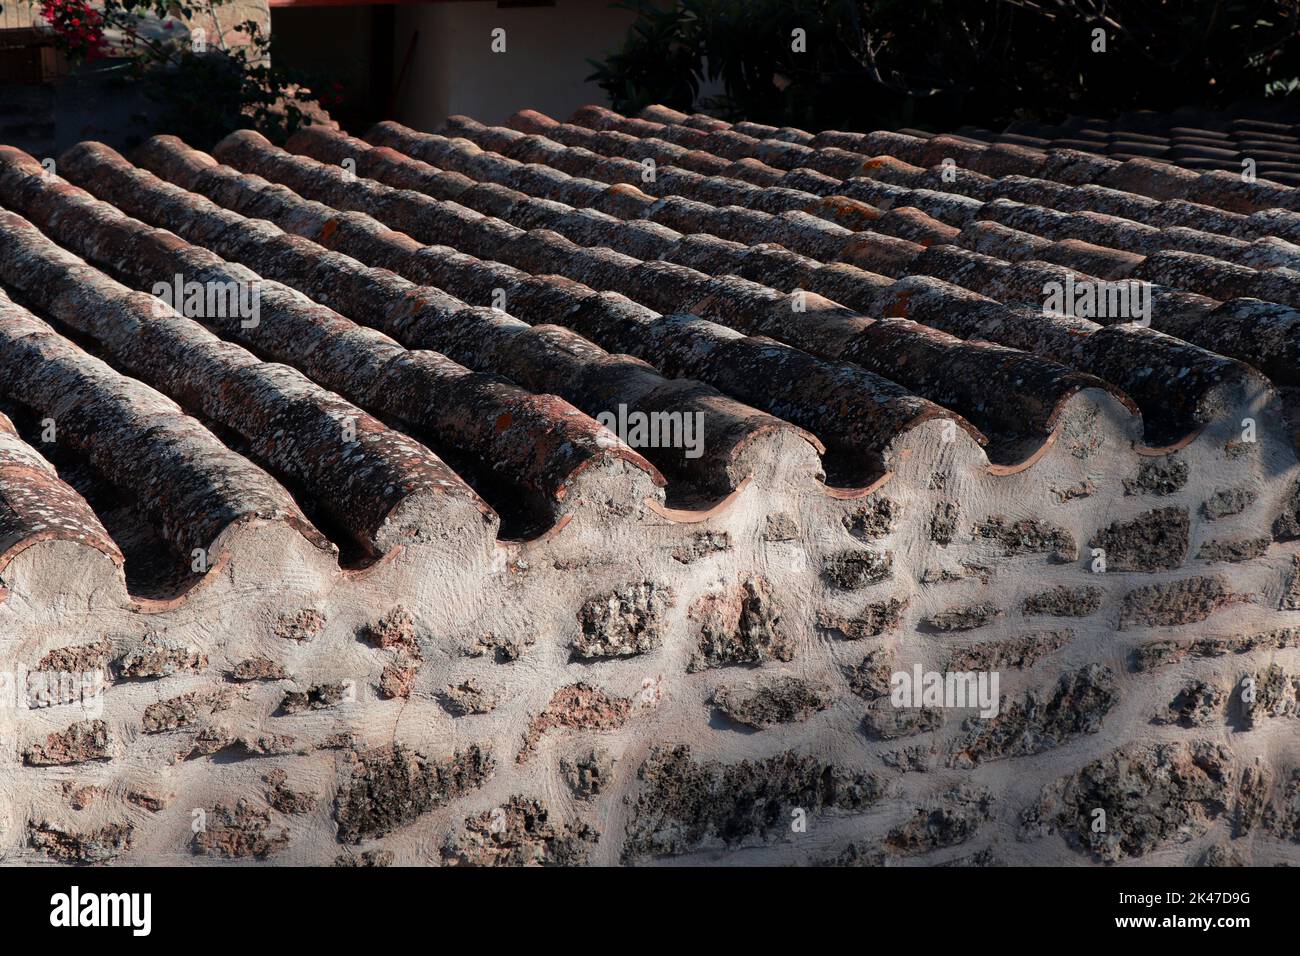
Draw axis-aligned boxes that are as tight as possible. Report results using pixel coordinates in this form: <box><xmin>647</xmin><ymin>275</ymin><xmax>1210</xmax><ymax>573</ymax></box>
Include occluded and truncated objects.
<box><xmin>1021</xmin><ymin>740</ymin><xmax>1234</xmax><ymax>862</ymax></box>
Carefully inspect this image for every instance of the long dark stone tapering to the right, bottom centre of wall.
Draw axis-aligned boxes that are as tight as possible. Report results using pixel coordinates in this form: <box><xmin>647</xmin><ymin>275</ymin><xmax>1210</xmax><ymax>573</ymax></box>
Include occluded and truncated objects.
<box><xmin>623</xmin><ymin>744</ymin><xmax>885</xmax><ymax>862</ymax></box>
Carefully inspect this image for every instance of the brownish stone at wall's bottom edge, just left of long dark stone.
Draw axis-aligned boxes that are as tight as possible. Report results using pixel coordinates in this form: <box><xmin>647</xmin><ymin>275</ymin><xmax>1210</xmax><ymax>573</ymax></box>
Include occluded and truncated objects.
<box><xmin>442</xmin><ymin>796</ymin><xmax>599</xmax><ymax>866</ymax></box>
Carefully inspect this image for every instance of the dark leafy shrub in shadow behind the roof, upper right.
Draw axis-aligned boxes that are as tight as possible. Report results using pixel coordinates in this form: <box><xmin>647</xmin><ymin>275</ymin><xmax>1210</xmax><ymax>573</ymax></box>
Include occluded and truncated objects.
<box><xmin>590</xmin><ymin>0</ymin><xmax>1300</xmax><ymax>129</ymax></box>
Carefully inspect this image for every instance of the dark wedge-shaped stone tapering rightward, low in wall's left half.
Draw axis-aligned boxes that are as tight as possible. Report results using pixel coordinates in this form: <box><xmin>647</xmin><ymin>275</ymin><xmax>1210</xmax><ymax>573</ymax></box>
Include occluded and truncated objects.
<box><xmin>334</xmin><ymin>744</ymin><xmax>494</xmax><ymax>843</ymax></box>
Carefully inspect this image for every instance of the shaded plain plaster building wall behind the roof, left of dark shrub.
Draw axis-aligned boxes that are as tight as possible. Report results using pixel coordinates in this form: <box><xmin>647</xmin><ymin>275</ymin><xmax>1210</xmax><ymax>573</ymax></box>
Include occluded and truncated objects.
<box><xmin>394</xmin><ymin>0</ymin><xmax>634</xmax><ymax>129</ymax></box>
